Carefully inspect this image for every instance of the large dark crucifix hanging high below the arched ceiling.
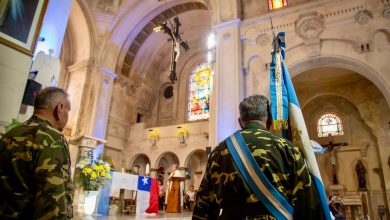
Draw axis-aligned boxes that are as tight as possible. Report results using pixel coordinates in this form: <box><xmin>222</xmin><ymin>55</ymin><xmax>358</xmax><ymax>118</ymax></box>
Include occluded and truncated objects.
<box><xmin>154</xmin><ymin>16</ymin><xmax>190</xmax><ymax>83</ymax></box>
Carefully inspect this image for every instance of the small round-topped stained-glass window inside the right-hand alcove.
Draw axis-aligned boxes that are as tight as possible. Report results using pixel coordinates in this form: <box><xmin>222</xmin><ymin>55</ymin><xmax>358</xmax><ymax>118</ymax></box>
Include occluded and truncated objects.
<box><xmin>317</xmin><ymin>113</ymin><xmax>344</xmax><ymax>137</ymax></box>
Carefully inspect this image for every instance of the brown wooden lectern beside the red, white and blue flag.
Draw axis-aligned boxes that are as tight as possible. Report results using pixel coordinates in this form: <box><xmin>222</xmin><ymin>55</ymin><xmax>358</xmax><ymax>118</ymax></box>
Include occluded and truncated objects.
<box><xmin>165</xmin><ymin>177</ymin><xmax>185</xmax><ymax>213</ymax></box>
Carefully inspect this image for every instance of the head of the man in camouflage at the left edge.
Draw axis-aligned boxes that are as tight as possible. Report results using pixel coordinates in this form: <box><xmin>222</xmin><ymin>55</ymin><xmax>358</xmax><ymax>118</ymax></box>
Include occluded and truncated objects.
<box><xmin>34</xmin><ymin>87</ymin><xmax>70</xmax><ymax>131</ymax></box>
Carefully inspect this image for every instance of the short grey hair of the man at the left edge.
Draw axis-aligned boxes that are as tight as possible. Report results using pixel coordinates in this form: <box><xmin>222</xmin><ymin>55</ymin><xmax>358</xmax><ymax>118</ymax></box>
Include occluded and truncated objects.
<box><xmin>34</xmin><ymin>87</ymin><xmax>69</xmax><ymax>109</ymax></box>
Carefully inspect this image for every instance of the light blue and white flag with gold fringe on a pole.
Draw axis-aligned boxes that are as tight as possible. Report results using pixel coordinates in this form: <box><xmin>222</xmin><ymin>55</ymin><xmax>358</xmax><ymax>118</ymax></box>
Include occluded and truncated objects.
<box><xmin>270</xmin><ymin>32</ymin><xmax>331</xmax><ymax>220</ymax></box>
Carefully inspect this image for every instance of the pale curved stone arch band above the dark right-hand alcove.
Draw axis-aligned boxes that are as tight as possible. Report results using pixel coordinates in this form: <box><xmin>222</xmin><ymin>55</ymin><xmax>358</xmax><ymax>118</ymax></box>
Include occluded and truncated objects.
<box><xmin>288</xmin><ymin>56</ymin><xmax>390</xmax><ymax>107</ymax></box>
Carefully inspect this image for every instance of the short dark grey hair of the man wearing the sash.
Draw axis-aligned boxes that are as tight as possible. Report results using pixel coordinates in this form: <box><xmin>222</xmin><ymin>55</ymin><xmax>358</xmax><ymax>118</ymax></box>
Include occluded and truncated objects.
<box><xmin>239</xmin><ymin>95</ymin><xmax>269</xmax><ymax>122</ymax></box>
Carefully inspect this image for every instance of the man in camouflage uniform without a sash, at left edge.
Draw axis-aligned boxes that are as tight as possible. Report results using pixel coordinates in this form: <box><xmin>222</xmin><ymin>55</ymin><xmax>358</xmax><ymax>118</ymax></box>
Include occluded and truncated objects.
<box><xmin>0</xmin><ymin>87</ymin><xmax>73</xmax><ymax>219</ymax></box>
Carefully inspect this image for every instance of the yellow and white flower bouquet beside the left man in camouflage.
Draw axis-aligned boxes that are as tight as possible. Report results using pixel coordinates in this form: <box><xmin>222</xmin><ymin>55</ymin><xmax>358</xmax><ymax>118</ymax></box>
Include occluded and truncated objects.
<box><xmin>76</xmin><ymin>151</ymin><xmax>111</xmax><ymax>191</ymax></box>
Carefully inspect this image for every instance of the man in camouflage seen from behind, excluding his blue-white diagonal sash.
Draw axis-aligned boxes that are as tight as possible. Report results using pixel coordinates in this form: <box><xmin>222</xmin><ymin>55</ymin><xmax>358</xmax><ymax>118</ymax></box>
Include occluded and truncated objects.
<box><xmin>192</xmin><ymin>95</ymin><xmax>321</xmax><ymax>220</ymax></box>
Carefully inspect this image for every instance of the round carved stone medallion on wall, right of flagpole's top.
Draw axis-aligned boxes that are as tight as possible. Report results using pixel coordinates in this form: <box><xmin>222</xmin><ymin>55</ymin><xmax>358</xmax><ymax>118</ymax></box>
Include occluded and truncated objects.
<box><xmin>294</xmin><ymin>12</ymin><xmax>325</xmax><ymax>40</ymax></box>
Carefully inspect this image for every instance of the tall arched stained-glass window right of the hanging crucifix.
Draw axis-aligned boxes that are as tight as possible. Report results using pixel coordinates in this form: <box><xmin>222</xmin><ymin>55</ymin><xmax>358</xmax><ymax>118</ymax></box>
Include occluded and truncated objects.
<box><xmin>187</xmin><ymin>62</ymin><xmax>211</xmax><ymax>121</ymax></box>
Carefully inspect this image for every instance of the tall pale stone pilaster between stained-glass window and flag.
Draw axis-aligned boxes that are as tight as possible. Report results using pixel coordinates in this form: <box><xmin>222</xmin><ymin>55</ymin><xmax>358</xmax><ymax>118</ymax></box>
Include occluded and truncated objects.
<box><xmin>209</xmin><ymin>19</ymin><xmax>244</xmax><ymax>146</ymax></box>
